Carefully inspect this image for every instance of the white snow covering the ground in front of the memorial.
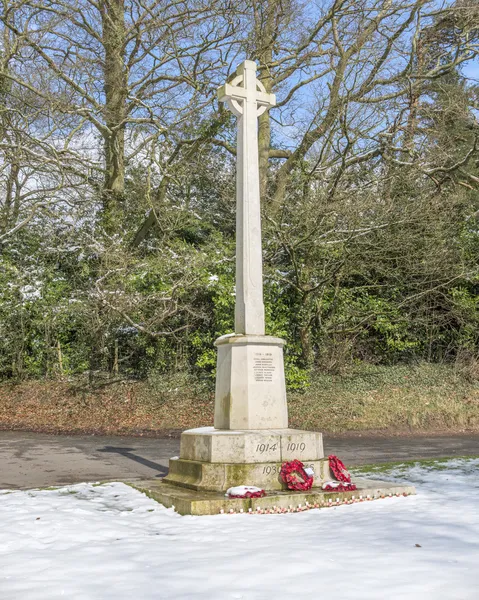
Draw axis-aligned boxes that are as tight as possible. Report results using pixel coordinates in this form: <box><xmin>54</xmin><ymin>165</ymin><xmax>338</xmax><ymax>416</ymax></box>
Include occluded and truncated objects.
<box><xmin>0</xmin><ymin>459</ymin><xmax>479</xmax><ymax>600</ymax></box>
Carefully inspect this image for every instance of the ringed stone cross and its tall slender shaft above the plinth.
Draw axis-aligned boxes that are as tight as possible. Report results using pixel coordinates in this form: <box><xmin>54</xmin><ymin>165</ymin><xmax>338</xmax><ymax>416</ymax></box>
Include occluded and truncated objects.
<box><xmin>218</xmin><ymin>60</ymin><xmax>276</xmax><ymax>335</ymax></box>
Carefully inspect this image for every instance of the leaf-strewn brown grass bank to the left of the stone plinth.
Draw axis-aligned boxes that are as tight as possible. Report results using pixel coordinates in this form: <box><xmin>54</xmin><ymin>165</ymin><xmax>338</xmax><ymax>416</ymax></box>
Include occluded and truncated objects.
<box><xmin>0</xmin><ymin>381</ymin><xmax>214</xmax><ymax>435</ymax></box>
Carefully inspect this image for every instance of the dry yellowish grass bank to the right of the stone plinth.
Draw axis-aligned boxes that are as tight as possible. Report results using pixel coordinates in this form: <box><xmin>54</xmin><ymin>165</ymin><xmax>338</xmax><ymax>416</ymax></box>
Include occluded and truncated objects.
<box><xmin>289</xmin><ymin>363</ymin><xmax>479</xmax><ymax>433</ymax></box>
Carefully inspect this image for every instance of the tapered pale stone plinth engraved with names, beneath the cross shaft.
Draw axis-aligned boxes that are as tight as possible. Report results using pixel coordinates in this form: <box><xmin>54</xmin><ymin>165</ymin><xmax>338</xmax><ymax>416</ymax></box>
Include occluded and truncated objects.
<box><xmin>214</xmin><ymin>334</ymin><xmax>288</xmax><ymax>430</ymax></box>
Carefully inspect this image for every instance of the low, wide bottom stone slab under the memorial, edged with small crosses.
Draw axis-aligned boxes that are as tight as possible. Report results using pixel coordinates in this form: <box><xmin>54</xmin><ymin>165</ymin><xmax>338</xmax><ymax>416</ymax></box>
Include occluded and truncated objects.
<box><xmin>134</xmin><ymin>477</ymin><xmax>416</xmax><ymax>515</ymax></box>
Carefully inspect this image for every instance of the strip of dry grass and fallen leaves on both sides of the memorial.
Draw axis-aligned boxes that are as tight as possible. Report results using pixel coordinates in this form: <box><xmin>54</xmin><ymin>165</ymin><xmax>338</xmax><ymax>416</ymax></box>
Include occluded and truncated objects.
<box><xmin>0</xmin><ymin>364</ymin><xmax>479</xmax><ymax>435</ymax></box>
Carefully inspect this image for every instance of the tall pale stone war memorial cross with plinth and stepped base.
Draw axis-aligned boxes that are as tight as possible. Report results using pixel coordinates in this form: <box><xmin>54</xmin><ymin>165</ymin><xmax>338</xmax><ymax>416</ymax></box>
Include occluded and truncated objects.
<box><xmin>162</xmin><ymin>60</ymin><xmax>329</xmax><ymax>504</ymax></box>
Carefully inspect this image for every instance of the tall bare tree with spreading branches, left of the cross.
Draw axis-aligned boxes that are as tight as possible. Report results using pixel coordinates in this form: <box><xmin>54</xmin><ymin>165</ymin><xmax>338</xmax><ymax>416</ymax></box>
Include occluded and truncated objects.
<box><xmin>2</xmin><ymin>0</ymin><xmax>238</xmax><ymax>232</ymax></box>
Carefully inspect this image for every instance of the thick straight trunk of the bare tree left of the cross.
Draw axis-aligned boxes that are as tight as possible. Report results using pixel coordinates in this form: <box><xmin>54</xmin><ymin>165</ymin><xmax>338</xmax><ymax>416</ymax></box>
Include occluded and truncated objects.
<box><xmin>101</xmin><ymin>0</ymin><xmax>128</xmax><ymax>232</ymax></box>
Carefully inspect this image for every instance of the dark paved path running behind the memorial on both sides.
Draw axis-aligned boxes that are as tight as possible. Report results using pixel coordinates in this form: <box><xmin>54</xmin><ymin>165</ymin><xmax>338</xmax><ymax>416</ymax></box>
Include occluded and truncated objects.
<box><xmin>0</xmin><ymin>431</ymin><xmax>479</xmax><ymax>489</ymax></box>
